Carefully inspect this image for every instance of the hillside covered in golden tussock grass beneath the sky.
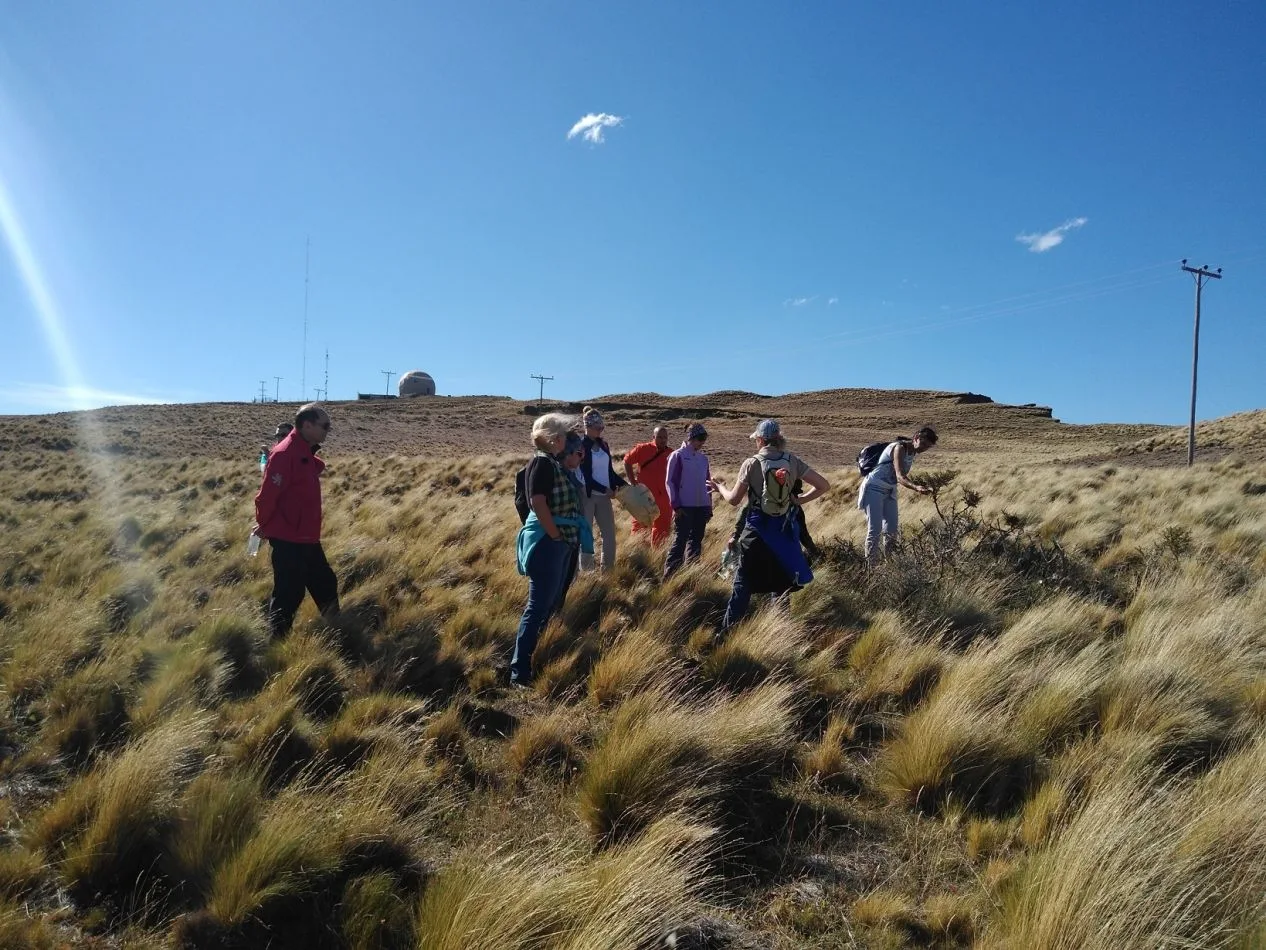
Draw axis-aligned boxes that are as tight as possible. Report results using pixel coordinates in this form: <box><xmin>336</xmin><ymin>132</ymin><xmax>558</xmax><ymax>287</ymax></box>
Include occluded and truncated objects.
<box><xmin>0</xmin><ymin>390</ymin><xmax>1266</xmax><ymax>950</ymax></box>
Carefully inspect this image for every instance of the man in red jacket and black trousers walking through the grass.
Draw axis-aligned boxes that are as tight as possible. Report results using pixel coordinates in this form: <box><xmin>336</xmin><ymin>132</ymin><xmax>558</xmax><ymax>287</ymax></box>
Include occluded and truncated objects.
<box><xmin>252</xmin><ymin>403</ymin><xmax>338</xmax><ymax>637</ymax></box>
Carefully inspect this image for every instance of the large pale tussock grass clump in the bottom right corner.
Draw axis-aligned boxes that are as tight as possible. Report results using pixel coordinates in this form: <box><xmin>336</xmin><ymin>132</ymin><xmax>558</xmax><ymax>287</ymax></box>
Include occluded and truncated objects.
<box><xmin>985</xmin><ymin>736</ymin><xmax>1266</xmax><ymax>950</ymax></box>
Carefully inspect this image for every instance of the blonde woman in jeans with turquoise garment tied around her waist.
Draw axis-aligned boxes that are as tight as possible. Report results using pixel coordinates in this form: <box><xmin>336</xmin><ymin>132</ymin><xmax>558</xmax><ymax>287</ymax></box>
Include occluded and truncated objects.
<box><xmin>510</xmin><ymin>413</ymin><xmax>594</xmax><ymax>687</ymax></box>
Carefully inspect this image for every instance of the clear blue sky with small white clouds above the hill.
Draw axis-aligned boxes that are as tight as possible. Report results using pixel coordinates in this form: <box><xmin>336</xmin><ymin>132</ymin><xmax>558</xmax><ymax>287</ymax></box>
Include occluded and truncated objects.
<box><xmin>0</xmin><ymin>0</ymin><xmax>1266</xmax><ymax>423</ymax></box>
